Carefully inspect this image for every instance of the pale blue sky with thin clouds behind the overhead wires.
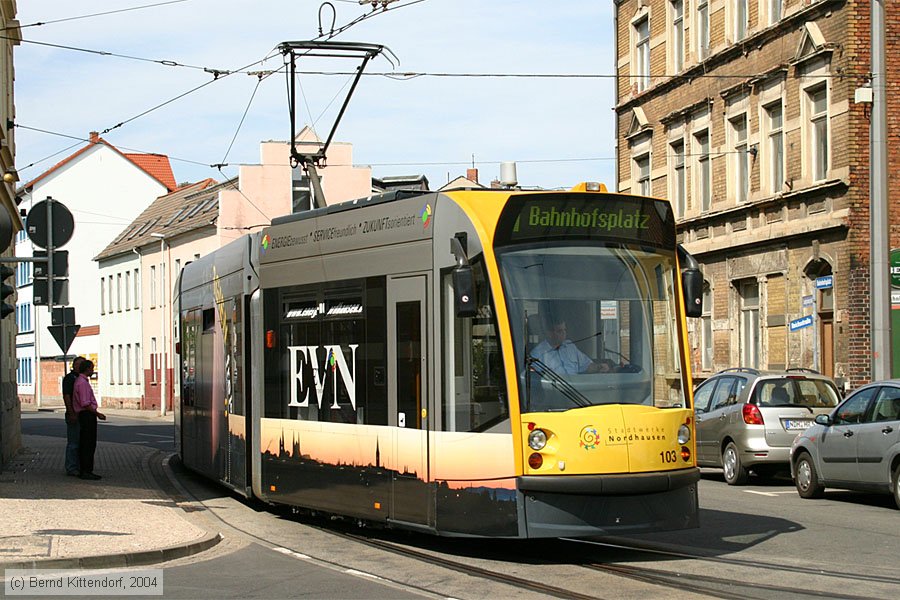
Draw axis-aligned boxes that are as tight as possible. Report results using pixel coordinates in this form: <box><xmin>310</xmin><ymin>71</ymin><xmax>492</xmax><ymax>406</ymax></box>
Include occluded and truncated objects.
<box><xmin>14</xmin><ymin>0</ymin><xmax>615</xmax><ymax>195</ymax></box>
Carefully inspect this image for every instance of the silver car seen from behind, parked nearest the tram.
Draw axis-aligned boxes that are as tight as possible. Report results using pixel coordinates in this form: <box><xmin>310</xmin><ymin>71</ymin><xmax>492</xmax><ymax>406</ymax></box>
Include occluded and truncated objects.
<box><xmin>694</xmin><ymin>368</ymin><xmax>840</xmax><ymax>485</ymax></box>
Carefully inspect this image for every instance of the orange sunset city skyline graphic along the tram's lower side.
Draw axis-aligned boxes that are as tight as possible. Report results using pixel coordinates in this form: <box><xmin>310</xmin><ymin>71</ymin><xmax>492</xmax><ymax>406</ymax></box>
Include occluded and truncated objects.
<box><xmin>262</xmin><ymin>419</ymin><xmax>518</xmax><ymax>535</ymax></box>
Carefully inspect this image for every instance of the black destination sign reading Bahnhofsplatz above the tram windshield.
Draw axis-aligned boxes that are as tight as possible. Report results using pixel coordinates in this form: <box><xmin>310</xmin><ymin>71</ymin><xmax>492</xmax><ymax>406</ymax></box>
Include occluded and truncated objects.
<box><xmin>496</xmin><ymin>192</ymin><xmax>675</xmax><ymax>248</ymax></box>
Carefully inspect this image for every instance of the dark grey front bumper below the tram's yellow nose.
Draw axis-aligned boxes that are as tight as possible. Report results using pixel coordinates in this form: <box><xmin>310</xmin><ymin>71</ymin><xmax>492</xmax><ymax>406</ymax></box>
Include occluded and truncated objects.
<box><xmin>518</xmin><ymin>468</ymin><xmax>700</xmax><ymax>538</ymax></box>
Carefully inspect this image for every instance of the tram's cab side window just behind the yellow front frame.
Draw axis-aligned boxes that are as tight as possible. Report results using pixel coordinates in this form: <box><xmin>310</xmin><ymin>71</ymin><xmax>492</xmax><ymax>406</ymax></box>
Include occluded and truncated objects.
<box><xmin>441</xmin><ymin>261</ymin><xmax>510</xmax><ymax>432</ymax></box>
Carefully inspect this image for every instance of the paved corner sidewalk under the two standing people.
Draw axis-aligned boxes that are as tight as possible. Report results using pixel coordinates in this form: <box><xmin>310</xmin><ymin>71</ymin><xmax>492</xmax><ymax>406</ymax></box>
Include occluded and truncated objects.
<box><xmin>0</xmin><ymin>407</ymin><xmax>221</xmax><ymax>576</ymax></box>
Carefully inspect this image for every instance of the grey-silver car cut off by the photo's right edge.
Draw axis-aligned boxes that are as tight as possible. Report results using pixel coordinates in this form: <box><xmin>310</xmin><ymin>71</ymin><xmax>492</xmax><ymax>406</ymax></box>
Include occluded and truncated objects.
<box><xmin>791</xmin><ymin>379</ymin><xmax>900</xmax><ymax>508</ymax></box>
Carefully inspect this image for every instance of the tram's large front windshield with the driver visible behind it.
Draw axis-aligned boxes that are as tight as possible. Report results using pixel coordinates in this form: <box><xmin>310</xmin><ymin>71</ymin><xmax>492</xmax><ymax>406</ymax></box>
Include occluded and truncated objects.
<box><xmin>498</xmin><ymin>242</ymin><xmax>686</xmax><ymax>412</ymax></box>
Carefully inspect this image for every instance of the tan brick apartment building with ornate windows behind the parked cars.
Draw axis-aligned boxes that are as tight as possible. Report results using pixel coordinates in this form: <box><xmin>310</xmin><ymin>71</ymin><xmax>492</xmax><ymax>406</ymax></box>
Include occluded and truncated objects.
<box><xmin>615</xmin><ymin>0</ymin><xmax>900</xmax><ymax>387</ymax></box>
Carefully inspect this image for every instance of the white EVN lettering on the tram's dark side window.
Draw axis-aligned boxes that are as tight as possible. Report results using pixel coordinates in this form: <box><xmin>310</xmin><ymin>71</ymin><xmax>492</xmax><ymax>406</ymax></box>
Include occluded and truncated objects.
<box><xmin>288</xmin><ymin>344</ymin><xmax>359</xmax><ymax>410</ymax></box>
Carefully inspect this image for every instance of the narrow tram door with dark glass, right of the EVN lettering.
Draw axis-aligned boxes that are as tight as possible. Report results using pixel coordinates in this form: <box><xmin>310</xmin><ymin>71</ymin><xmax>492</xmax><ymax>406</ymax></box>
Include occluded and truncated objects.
<box><xmin>387</xmin><ymin>275</ymin><xmax>434</xmax><ymax>525</ymax></box>
